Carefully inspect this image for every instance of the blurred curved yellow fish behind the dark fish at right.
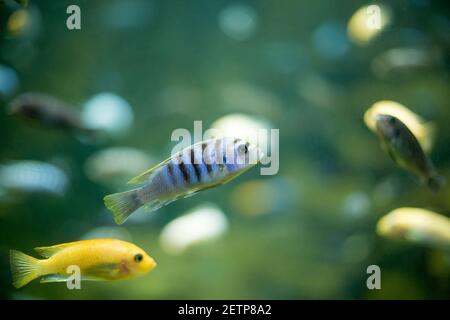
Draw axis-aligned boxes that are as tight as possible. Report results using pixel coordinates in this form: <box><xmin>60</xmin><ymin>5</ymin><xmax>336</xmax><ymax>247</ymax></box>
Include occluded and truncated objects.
<box><xmin>364</xmin><ymin>100</ymin><xmax>435</xmax><ymax>153</ymax></box>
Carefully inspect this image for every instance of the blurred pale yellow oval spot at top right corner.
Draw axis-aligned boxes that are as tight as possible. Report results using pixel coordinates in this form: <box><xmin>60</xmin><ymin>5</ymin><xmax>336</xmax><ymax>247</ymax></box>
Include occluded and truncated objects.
<box><xmin>347</xmin><ymin>5</ymin><xmax>392</xmax><ymax>45</ymax></box>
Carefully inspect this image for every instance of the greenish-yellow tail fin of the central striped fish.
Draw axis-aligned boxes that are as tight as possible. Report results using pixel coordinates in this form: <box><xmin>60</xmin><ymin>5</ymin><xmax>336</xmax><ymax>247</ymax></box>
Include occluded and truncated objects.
<box><xmin>103</xmin><ymin>189</ymin><xmax>144</xmax><ymax>224</ymax></box>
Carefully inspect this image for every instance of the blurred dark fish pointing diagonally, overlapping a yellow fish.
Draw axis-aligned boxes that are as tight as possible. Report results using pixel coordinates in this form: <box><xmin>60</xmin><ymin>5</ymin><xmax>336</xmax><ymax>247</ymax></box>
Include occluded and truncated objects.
<box><xmin>376</xmin><ymin>114</ymin><xmax>444</xmax><ymax>191</ymax></box>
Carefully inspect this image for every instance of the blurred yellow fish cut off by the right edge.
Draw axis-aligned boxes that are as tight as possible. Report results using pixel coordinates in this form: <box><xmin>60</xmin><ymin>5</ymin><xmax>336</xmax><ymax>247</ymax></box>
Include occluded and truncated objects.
<box><xmin>377</xmin><ymin>207</ymin><xmax>450</xmax><ymax>249</ymax></box>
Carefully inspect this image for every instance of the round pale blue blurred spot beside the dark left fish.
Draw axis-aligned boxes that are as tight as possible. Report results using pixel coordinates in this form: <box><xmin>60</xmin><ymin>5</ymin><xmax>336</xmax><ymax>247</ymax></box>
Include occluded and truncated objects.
<box><xmin>82</xmin><ymin>93</ymin><xmax>134</xmax><ymax>136</ymax></box>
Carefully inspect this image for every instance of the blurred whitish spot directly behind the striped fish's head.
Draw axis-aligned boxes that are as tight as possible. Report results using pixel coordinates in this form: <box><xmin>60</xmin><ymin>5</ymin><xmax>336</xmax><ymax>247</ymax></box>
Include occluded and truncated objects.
<box><xmin>211</xmin><ymin>113</ymin><xmax>276</xmax><ymax>152</ymax></box>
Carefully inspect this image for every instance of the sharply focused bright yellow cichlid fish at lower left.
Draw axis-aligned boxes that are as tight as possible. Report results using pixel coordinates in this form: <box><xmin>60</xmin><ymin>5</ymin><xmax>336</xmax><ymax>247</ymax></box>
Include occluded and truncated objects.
<box><xmin>10</xmin><ymin>239</ymin><xmax>156</xmax><ymax>288</ymax></box>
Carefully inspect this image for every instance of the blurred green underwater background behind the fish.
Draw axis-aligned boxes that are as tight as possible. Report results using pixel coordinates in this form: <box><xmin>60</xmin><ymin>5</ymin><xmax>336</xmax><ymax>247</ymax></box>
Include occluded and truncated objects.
<box><xmin>0</xmin><ymin>0</ymin><xmax>450</xmax><ymax>299</ymax></box>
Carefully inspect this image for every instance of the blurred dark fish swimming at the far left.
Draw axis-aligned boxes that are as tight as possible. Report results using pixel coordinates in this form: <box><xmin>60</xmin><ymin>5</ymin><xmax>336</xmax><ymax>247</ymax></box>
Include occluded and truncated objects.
<box><xmin>9</xmin><ymin>93</ymin><xmax>97</xmax><ymax>138</ymax></box>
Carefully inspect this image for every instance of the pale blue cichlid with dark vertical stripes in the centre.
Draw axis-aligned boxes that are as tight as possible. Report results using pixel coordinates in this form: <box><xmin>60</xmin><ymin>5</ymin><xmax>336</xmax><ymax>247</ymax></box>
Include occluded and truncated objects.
<box><xmin>104</xmin><ymin>137</ymin><xmax>262</xmax><ymax>224</ymax></box>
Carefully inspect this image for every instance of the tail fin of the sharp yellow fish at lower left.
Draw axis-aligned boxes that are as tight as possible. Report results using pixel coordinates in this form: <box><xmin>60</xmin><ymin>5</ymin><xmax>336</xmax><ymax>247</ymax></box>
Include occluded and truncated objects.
<box><xmin>9</xmin><ymin>250</ymin><xmax>41</xmax><ymax>288</ymax></box>
